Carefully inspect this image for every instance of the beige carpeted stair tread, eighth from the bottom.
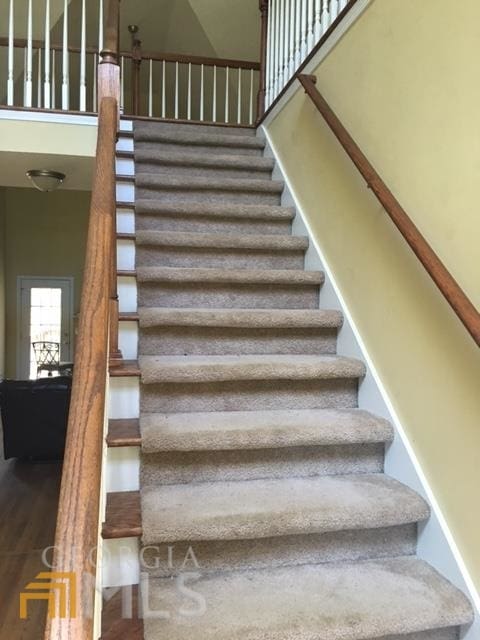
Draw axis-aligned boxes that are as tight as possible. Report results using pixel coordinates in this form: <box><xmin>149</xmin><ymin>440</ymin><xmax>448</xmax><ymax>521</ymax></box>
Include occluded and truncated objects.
<box><xmin>135</xmin><ymin>198</ymin><xmax>295</xmax><ymax>220</ymax></box>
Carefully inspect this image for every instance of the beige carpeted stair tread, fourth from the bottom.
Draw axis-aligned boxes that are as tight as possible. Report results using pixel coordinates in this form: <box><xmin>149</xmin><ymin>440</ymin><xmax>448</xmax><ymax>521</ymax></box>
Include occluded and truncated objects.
<box><xmin>138</xmin><ymin>355</ymin><xmax>365</xmax><ymax>384</ymax></box>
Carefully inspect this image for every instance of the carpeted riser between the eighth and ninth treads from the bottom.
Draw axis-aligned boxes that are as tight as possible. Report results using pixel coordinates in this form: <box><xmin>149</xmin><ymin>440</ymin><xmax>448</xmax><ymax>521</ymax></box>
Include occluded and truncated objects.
<box><xmin>136</xmin><ymin>188</ymin><xmax>281</xmax><ymax>206</ymax></box>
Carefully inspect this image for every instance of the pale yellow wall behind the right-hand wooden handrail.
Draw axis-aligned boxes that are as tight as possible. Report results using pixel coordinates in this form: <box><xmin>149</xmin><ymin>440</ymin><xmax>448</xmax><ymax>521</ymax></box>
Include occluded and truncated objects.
<box><xmin>268</xmin><ymin>0</ymin><xmax>480</xmax><ymax>589</ymax></box>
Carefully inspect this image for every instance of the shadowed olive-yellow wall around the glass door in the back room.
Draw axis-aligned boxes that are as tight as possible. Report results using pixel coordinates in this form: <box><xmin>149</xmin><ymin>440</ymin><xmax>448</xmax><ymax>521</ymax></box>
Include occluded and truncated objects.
<box><xmin>5</xmin><ymin>188</ymin><xmax>90</xmax><ymax>377</ymax></box>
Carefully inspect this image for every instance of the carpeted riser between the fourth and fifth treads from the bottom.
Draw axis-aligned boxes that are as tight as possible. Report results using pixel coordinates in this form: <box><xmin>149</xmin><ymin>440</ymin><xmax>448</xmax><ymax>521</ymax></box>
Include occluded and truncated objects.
<box><xmin>139</xmin><ymin>326</ymin><xmax>337</xmax><ymax>356</ymax></box>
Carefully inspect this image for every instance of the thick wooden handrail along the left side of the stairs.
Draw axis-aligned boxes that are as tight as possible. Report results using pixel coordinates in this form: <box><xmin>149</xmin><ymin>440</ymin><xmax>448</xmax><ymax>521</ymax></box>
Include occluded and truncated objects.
<box><xmin>45</xmin><ymin>98</ymin><xmax>118</xmax><ymax>640</ymax></box>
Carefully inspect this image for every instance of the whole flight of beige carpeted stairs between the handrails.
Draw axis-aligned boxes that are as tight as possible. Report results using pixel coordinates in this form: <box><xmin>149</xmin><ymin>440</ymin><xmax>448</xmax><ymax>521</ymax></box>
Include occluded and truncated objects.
<box><xmin>134</xmin><ymin>122</ymin><xmax>472</xmax><ymax>640</ymax></box>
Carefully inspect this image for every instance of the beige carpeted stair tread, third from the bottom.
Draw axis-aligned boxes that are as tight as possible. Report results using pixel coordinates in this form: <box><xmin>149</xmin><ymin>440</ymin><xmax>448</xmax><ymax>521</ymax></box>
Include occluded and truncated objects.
<box><xmin>140</xmin><ymin>409</ymin><xmax>393</xmax><ymax>453</ymax></box>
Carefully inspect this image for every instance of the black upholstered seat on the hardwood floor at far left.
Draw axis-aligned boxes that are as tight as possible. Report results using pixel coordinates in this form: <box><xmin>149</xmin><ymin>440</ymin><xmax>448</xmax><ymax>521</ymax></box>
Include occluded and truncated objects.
<box><xmin>0</xmin><ymin>376</ymin><xmax>72</xmax><ymax>460</ymax></box>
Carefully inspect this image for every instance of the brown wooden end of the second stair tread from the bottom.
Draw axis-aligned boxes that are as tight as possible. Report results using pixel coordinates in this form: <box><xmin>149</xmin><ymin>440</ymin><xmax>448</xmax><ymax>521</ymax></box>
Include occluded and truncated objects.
<box><xmin>103</xmin><ymin>491</ymin><xmax>142</xmax><ymax>536</ymax></box>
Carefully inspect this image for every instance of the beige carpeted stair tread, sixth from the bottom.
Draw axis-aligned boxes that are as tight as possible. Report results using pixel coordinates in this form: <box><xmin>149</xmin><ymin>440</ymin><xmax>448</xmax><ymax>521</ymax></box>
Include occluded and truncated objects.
<box><xmin>137</xmin><ymin>267</ymin><xmax>325</xmax><ymax>285</ymax></box>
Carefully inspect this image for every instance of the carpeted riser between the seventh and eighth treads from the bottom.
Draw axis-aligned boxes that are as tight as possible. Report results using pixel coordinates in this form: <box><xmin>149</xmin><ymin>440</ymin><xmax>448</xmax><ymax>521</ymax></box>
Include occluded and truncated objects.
<box><xmin>136</xmin><ymin>214</ymin><xmax>292</xmax><ymax>235</ymax></box>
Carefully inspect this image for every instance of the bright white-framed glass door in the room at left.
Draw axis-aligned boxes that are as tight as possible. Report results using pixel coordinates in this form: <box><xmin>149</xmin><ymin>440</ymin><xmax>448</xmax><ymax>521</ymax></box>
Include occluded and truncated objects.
<box><xmin>17</xmin><ymin>276</ymin><xmax>73</xmax><ymax>380</ymax></box>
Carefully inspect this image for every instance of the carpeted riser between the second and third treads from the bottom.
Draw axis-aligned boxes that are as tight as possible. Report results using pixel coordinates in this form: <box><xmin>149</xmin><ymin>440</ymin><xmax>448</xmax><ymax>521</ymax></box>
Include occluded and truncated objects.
<box><xmin>140</xmin><ymin>444</ymin><xmax>385</xmax><ymax>487</ymax></box>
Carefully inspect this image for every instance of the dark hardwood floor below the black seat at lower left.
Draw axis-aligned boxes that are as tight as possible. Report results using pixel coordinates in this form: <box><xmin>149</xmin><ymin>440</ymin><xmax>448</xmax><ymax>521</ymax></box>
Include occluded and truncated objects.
<box><xmin>0</xmin><ymin>430</ymin><xmax>61</xmax><ymax>640</ymax></box>
